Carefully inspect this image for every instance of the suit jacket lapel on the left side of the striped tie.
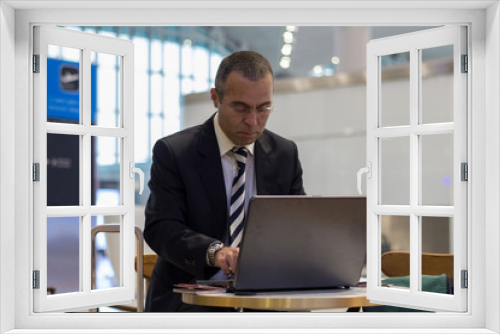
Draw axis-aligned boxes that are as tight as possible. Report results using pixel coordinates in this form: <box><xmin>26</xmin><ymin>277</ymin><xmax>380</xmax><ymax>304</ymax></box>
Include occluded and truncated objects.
<box><xmin>197</xmin><ymin>116</ymin><xmax>227</xmax><ymax>233</ymax></box>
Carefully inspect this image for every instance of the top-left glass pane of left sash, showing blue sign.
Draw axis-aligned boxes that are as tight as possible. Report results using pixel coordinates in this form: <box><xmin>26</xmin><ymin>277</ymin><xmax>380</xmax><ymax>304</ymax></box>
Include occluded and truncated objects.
<box><xmin>47</xmin><ymin>45</ymin><xmax>81</xmax><ymax>124</ymax></box>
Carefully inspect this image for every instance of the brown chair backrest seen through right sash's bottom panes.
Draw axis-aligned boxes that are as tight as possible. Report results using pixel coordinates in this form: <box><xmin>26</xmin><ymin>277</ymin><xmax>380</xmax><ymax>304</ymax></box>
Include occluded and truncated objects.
<box><xmin>382</xmin><ymin>251</ymin><xmax>453</xmax><ymax>284</ymax></box>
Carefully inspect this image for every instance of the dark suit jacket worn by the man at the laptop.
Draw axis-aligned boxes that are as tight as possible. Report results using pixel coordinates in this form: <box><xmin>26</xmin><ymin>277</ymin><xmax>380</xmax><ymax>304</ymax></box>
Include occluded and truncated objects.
<box><xmin>144</xmin><ymin>116</ymin><xmax>304</xmax><ymax>312</ymax></box>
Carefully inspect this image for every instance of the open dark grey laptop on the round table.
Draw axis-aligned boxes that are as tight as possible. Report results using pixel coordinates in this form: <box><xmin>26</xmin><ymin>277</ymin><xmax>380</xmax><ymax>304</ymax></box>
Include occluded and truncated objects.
<box><xmin>200</xmin><ymin>195</ymin><xmax>366</xmax><ymax>293</ymax></box>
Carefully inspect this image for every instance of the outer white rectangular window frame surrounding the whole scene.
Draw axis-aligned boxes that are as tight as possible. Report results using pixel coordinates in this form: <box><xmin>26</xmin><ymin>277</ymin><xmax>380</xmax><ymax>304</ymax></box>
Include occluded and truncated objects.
<box><xmin>0</xmin><ymin>1</ymin><xmax>500</xmax><ymax>333</ymax></box>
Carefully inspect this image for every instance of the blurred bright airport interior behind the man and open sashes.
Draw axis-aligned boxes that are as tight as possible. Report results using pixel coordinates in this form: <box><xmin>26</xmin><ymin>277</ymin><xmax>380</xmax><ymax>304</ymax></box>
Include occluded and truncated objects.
<box><xmin>47</xmin><ymin>26</ymin><xmax>453</xmax><ymax>311</ymax></box>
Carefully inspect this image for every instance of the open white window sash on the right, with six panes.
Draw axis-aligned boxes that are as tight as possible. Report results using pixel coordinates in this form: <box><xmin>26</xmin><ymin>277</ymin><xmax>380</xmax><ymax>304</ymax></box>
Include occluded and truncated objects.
<box><xmin>366</xmin><ymin>25</ymin><xmax>468</xmax><ymax>312</ymax></box>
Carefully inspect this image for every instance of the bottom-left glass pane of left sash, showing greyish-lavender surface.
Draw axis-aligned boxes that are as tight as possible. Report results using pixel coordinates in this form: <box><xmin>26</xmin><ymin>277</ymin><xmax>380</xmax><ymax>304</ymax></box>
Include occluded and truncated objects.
<box><xmin>47</xmin><ymin>217</ymin><xmax>81</xmax><ymax>294</ymax></box>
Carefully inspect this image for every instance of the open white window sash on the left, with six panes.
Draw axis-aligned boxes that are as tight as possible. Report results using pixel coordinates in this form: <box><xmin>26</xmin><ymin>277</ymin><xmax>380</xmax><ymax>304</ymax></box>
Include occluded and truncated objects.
<box><xmin>33</xmin><ymin>26</ymin><xmax>135</xmax><ymax>312</ymax></box>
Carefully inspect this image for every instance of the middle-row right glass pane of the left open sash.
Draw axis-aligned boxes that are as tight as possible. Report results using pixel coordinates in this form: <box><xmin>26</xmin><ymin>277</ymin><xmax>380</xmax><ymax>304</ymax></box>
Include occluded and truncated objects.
<box><xmin>92</xmin><ymin>137</ymin><xmax>121</xmax><ymax>206</ymax></box>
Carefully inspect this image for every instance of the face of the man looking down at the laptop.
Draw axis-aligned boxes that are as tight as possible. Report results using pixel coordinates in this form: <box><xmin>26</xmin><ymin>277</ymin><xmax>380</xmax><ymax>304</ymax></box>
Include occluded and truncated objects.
<box><xmin>210</xmin><ymin>72</ymin><xmax>273</xmax><ymax>146</ymax></box>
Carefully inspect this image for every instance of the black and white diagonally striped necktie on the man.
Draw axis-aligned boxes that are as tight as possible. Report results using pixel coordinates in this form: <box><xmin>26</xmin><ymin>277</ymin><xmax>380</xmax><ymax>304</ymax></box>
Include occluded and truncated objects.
<box><xmin>229</xmin><ymin>147</ymin><xmax>248</xmax><ymax>247</ymax></box>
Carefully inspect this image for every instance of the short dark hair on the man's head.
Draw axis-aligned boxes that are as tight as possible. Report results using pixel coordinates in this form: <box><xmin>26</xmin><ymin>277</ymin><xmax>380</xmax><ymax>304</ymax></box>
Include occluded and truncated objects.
<box><xmin>215</xmin><ymin>51</ymin><xmax>274</xmax><ymax>100</ymax></box>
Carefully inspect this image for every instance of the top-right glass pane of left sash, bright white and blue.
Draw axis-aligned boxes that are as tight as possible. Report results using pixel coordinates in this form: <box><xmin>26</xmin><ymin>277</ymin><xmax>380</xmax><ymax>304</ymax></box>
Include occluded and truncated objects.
<box><xmin>91</xmin><ymin>52</ymin><xmax>121</xmax><ymax>127</ymax></box>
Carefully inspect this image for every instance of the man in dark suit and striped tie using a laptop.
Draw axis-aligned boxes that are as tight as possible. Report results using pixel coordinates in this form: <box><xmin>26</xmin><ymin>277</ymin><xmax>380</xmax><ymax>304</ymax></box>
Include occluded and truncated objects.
<box><xmin>144</xmin><ymin>51</ymin><xmax>304</xmax><ymax>312</ymax></box>
